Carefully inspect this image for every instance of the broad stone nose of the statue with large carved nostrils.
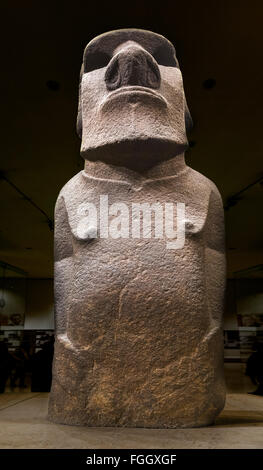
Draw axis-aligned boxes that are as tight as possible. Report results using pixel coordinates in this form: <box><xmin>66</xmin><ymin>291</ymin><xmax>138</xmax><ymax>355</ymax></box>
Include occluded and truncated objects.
<box><xmin>105</xmin><ymin>47</ymin><xmax>161</xmax><ymax>90</ymax></box>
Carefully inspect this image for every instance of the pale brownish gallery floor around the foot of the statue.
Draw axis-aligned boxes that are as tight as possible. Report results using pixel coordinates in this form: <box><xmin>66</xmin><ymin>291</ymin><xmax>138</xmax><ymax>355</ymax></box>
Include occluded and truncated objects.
<box><xmin>0</xmin><ymin>363</ymin><xmax>263</xmax><ymax>449</ymax></box>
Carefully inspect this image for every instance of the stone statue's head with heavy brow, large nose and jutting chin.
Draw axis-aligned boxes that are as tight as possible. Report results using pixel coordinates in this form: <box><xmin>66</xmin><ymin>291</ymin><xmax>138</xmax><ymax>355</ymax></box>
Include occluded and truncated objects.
<box><xmin>77</xmin><ymin>29</ymin><xmax>192</xmax><ymax>165</ymax></box>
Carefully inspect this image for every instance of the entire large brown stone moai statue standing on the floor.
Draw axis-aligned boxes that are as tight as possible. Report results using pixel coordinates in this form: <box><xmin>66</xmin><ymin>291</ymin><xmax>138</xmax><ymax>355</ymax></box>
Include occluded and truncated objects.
<box><xmin>49</xmin><ymin>29</ymin><xmax>225</xmax><ymax>428</ymax></box>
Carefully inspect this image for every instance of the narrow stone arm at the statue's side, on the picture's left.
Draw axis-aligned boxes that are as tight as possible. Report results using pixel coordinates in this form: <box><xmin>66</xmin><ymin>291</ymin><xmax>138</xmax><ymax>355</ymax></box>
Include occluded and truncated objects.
<box><xmin>54</xmin><ymin>195</ymin><xmax>73</xmax><ymax>335</ymax></box>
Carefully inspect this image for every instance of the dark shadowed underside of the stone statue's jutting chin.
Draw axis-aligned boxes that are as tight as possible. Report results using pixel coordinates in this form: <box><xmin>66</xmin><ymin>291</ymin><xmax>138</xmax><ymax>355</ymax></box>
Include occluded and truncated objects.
<box><xmin>80</xmin><ymin>136</ymin><xmax>188</xmax><ymax>171</ymax></box>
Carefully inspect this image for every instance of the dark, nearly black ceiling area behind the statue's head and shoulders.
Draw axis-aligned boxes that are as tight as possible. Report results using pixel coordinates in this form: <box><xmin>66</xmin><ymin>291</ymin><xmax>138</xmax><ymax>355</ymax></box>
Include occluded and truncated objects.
<box><xmin>0</xmin><ymin>0</ymin><xmax>263</xmax><ymax>278</ymax></box>
